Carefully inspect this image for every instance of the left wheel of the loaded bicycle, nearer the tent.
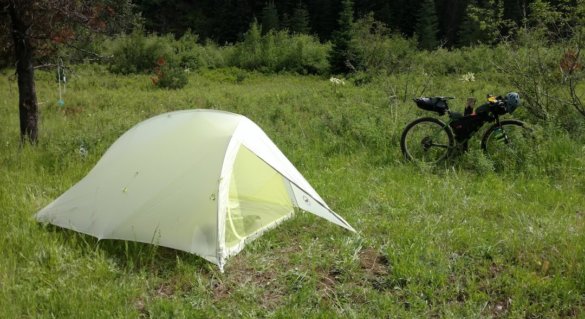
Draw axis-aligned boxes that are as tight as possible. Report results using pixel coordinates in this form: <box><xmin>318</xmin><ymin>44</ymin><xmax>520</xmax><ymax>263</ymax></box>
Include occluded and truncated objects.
<box><xmin>400</xmin><ymin>117</ymin><xmax>455</xmax><ymax>164</ymax></box>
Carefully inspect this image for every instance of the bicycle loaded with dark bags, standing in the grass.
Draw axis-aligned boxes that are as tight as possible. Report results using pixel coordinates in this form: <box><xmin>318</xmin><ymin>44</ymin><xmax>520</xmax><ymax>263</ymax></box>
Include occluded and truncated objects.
<box><xmin>400</xmin><ymin>92</ymin><xmax>533</xmax><ymax>165</ymax></box>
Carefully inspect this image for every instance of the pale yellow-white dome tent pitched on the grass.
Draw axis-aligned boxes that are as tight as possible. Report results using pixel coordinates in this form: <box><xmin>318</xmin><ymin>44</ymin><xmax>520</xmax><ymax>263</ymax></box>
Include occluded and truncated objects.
<box><xmin>36</xmin><ymin>110</ymin><xmax>354</xmax><ymax>271</ymax></box>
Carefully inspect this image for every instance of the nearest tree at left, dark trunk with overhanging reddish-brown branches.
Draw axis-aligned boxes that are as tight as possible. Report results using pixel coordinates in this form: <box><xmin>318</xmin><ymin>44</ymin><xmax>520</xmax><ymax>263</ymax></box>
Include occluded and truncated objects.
<box><xmin>0</xmin><ymin>0</ymin><xmax>129</xmax><ymax>145</ymax></box>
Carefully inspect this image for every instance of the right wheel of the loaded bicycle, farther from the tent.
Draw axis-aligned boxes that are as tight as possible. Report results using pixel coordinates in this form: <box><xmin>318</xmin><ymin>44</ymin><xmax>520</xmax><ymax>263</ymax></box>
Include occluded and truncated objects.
<box><xmin>481</xmin><ymin>120</ymin><xmax>537</xmax><ymax>170</ymax></box>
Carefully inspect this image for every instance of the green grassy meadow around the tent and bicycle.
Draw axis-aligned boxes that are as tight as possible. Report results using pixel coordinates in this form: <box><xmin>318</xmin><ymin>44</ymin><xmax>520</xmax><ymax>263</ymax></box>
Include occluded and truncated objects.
<box><xmin>0</xmin><ymin>66</ymin><xmax>585</xmax><ymax>318</ymax></box>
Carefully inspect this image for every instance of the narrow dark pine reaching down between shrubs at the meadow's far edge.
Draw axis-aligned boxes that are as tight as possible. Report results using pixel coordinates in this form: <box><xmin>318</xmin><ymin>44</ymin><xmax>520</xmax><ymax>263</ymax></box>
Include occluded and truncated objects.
<box><xmin>329</xmin><ymin>0</ymin><xmax>353</xmax><ymax>74</ymax></box>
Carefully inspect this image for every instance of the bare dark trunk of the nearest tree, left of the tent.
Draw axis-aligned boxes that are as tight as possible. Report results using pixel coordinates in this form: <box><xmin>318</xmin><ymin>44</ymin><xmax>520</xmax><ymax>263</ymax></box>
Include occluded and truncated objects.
<box><xmin>9</xmin><ymin>1</ymin><xmax>39</xmax><ymax>145</ymax></box>
